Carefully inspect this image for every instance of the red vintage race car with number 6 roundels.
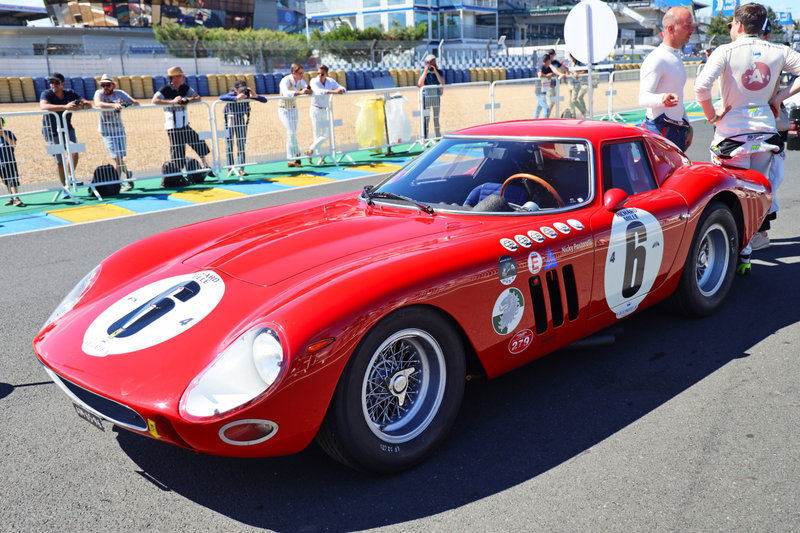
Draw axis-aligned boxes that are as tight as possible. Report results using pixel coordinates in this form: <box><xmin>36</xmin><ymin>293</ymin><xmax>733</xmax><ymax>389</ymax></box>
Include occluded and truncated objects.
<box><xmin>33</xmin><ymin>120</ymin><xmax>771</xmax><ymax>472</ymax></box>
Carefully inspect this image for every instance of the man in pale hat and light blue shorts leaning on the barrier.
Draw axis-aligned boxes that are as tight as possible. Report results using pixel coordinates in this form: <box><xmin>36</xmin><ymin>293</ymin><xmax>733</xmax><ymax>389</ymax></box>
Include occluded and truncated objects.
<box><xmin>94</xmin><ymin>74</ymin><xmax>139</xmax><ymax>191</ymax></box>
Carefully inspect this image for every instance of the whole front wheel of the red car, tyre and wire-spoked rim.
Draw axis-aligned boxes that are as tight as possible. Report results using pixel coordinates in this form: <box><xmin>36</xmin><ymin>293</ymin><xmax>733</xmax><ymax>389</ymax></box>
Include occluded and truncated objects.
<box><xmin>317</xmin><ymin>308</ymin><xmax>466</xmax><ymax>473</ymax></box>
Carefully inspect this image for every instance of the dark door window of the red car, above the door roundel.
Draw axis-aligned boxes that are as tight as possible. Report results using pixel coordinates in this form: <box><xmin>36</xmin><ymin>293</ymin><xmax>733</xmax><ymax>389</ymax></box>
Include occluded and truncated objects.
<box><xmin>603</xmin><ymin>140</ymin><xmax>656</xmax><ymax>195</ymax></box>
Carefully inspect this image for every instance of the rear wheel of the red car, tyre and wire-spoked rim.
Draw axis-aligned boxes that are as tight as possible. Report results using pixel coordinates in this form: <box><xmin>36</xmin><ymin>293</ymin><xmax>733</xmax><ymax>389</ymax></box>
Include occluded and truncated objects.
<box><xmin>672</xmin><ymin>202</ymin><xmax>739</xmax><ymax>317</ymax></box>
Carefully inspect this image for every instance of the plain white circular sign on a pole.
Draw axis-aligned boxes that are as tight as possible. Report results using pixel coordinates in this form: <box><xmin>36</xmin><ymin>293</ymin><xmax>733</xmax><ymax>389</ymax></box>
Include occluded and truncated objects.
<box><xmin>564</xmin><ymin>0</ymin><xmax>617</xmax><ymax>63</ymax></box>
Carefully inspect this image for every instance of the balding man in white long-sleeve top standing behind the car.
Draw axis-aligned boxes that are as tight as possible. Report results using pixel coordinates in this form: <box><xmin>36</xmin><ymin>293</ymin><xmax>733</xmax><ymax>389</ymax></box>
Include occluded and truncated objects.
<box><xmin>639</xmin><ymin>7</ymin><xmax>694</xmax><ymax>150</ymax></box>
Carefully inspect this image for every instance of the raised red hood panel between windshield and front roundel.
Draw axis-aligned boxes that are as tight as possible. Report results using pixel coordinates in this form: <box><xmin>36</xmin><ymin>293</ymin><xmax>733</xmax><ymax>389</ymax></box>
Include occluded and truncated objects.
<box><xmin>184</xmin><ymin>199</ymin><xmax>454</xmax><ymax>286</ymax></box>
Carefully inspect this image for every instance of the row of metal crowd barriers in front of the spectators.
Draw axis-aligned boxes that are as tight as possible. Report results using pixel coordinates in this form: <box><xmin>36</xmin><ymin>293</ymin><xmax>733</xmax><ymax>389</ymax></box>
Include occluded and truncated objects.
<box><xmin>0</xmin><ymin>70</ymin><xmax>720</xmax><ymax>203</ymax></box>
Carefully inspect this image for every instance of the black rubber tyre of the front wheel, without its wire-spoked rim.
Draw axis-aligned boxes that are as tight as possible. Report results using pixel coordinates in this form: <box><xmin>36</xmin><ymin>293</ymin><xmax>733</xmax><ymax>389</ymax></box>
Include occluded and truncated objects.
<box><xmin>330</xmin><ymin>309</ymin><xmax>466</xmax><ymax>473</ymax></box>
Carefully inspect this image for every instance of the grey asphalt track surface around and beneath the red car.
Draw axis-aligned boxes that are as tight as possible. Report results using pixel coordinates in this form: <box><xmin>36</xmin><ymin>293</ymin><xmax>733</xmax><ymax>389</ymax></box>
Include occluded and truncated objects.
<box><xmin>0</xmin><ymin>124</ymin><xmax>800</xmax><ymax>532</ymax></box>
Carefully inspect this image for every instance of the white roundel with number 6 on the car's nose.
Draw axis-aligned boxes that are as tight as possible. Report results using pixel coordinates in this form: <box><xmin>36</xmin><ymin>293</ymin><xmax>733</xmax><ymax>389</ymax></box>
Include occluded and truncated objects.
<box><xmin>83</xmin><ymin>270</ymin><xmax>225</xmax><ymax>357</ymax></box>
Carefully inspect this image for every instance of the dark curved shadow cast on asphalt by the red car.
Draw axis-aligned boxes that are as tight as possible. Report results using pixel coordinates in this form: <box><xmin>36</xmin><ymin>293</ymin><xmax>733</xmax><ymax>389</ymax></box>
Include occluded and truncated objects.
<box><xmin>112</xmin><ymin>240</ymin><xmax>800</xmax><ymax>531</ymax></box>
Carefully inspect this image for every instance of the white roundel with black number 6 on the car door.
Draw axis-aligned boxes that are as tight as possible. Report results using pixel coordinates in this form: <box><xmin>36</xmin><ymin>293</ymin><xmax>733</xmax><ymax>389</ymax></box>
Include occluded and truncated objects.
<box><xmin>605</xmin><ymin>208</ymin><xmax>664</xmax><ymax>318</ymax></box>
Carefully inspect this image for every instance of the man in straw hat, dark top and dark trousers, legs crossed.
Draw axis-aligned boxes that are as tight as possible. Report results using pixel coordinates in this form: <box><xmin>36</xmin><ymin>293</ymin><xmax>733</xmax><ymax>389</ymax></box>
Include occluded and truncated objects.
<box><xmin>152</xmin><ymin>67</ymin><xmax>213</xmax><ymax>175</ymax></box>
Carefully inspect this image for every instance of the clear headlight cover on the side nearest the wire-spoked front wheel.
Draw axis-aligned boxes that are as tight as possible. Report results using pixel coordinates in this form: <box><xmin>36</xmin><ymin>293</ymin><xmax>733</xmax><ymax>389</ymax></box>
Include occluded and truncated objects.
<box><xmin>180</xmin><ymin>327</ymin><xmax>283</xmax><ymax>419</ymax></box>
